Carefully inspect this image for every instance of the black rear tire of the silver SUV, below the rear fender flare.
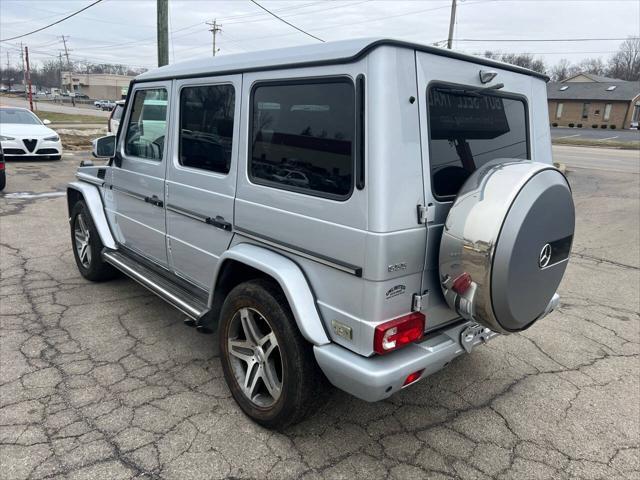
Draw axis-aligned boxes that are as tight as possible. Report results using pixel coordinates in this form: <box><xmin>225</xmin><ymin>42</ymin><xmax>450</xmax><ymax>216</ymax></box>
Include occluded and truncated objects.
<box><xmin>218</xmin><ymin>279</ymin><xmax>330</xmax><ymax>429</ymax></box>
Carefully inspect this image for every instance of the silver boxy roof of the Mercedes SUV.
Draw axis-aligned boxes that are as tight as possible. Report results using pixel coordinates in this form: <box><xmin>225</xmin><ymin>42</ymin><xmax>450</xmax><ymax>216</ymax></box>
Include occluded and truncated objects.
<box><xmin>135</xmin><ymin>38</ymin><xmax>549</xmax><ymax>82</ymax></box>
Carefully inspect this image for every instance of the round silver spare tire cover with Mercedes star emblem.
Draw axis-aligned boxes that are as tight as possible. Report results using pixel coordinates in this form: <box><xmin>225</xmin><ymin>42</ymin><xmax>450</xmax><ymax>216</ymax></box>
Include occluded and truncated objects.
<box><xmin>440</xmin><ymin>159</ymin><xmax>575</xmax><ymax>333</ymax></box>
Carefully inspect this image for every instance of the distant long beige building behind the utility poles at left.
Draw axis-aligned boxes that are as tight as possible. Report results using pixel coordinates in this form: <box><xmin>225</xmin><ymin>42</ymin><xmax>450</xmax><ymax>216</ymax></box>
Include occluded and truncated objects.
<box><xmin>62</xmin><ymin>72</ymin><xmax>134</xmax><ymax>100</ymax></box>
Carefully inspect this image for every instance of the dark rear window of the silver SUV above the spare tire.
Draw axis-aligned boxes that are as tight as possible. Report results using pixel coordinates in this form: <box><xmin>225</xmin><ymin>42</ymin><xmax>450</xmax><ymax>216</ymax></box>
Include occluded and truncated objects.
<box><xmin>428</xmin><ymin>85</ymin><xmax>529</xmax><ymax>200</ymax></box>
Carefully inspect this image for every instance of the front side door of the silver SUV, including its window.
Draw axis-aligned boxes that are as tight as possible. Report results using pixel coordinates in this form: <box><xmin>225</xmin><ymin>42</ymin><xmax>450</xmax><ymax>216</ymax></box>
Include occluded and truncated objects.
<box><xmin>107</xmin><ymin>82</ymin><xmax>171</xmax><ymax>268</ymax></box>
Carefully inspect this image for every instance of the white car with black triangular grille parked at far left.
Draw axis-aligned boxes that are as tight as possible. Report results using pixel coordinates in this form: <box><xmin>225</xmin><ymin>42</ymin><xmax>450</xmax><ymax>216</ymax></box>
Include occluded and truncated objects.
<box><xmin>0</xmin><ymin>107</ymin><xmax>62</xmax><ymax>160</ymax></box>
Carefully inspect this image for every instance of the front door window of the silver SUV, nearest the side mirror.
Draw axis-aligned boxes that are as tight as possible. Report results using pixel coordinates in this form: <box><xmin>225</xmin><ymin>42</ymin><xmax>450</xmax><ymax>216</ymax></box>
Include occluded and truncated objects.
<box><xmin>124</xmin><ymin>88</ymin><xmax>167</xmax><ymax>161</ymax></box>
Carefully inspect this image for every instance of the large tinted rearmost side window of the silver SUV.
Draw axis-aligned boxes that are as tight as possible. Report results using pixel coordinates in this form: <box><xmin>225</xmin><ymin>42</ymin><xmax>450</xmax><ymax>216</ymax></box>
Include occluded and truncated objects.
<box><xmin>250</xmin><ymin>81</ymin><xmax>355</xmax><ymax>197</ymax></box>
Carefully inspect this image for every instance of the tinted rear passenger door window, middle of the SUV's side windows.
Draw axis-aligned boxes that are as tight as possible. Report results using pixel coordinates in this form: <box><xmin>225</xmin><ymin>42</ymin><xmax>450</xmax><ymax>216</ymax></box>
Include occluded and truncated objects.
<box><xmin>178</xmin><ymin>85</ymin><xmax>235</xmax><ymax>173</ymax></box>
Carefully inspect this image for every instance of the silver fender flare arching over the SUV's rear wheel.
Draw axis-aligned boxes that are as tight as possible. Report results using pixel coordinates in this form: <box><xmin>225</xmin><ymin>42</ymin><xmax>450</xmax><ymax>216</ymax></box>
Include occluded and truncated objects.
<box><xmin>211</xmin><ymin>243</ymin><xmax>330</xmax><ymax>345</ymax></box>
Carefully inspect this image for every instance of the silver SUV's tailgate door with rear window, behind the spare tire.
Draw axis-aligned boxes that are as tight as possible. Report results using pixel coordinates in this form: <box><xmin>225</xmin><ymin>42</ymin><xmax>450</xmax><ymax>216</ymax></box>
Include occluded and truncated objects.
<box><xmin>416</xmin><ymin>52</ymin><xmax>528</xmax><ymax>327</ymax></box>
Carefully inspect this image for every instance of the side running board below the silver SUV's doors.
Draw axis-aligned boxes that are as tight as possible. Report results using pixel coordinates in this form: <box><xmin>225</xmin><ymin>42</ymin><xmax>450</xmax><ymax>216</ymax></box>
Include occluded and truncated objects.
<box><xmin>102</xmin><ymin>248</ymin><xmax>209</xmax><ymax>323</ymax></box>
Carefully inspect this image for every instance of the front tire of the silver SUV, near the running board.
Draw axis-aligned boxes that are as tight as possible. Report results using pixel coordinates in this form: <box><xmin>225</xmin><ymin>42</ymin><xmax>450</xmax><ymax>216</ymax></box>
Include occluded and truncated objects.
<box><xmin>69</xmin><ymin>200</ymin><xmax>119</xmax><ymax>282</ymax></box>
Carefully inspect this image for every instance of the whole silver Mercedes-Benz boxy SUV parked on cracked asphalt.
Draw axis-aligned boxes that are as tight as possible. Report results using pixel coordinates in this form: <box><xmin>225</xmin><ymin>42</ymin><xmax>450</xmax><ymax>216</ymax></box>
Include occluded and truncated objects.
<box><xmin>67</xmin><ymin>39</ymin><xmax>575</xmax><ymax>428</ymax></box>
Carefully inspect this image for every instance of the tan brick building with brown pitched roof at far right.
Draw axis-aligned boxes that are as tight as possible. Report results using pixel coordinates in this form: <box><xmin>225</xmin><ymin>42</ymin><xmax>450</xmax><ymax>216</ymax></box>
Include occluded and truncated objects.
<box><xmin>547</xmin><ymin>73</ymin><xmax>640</xmax><ymax>129</ymax></box>
